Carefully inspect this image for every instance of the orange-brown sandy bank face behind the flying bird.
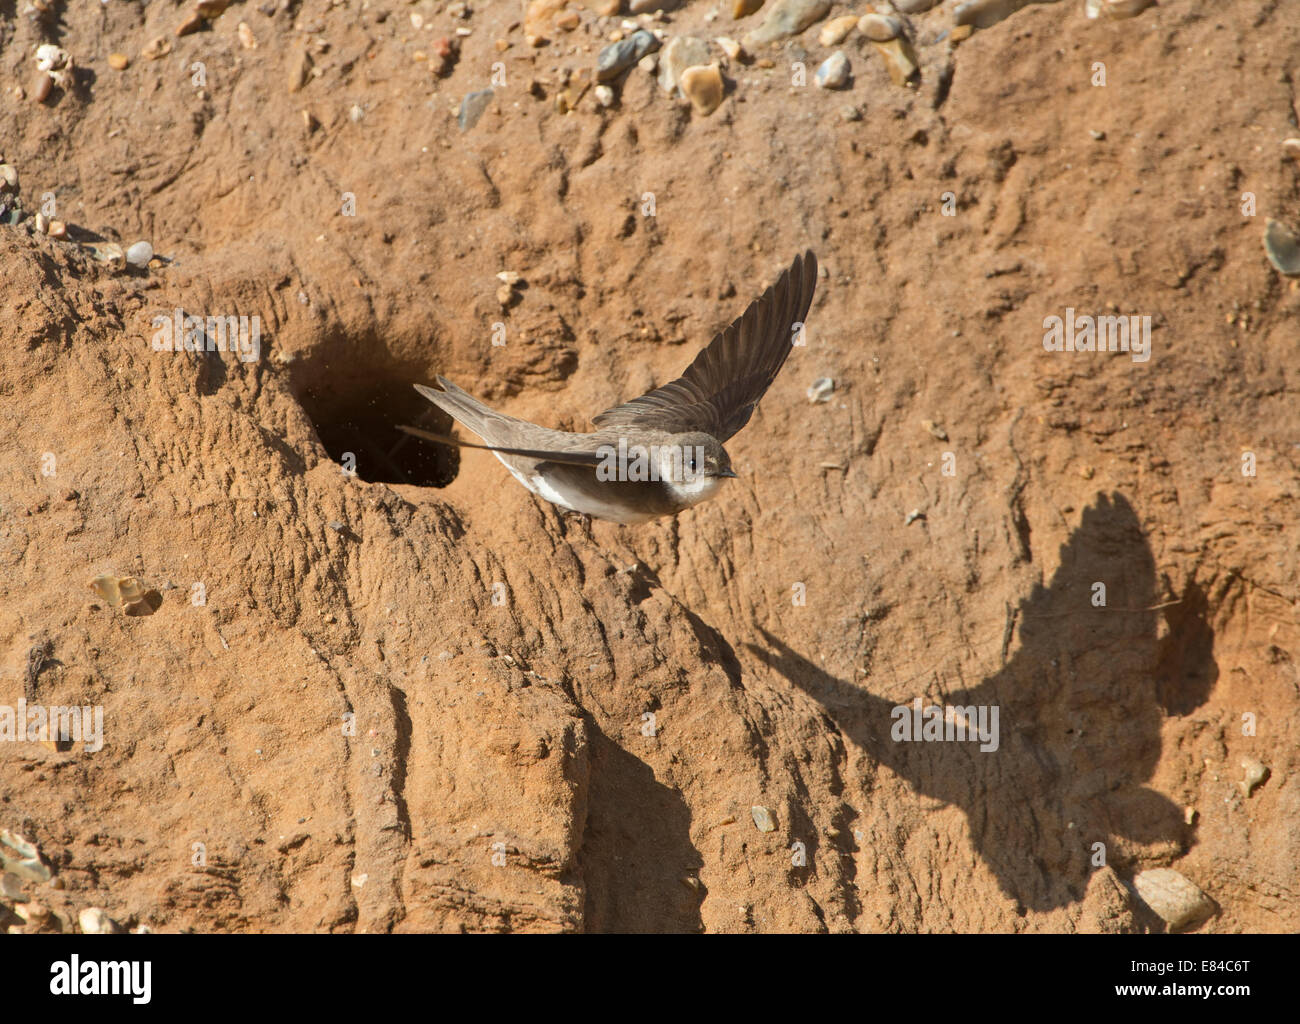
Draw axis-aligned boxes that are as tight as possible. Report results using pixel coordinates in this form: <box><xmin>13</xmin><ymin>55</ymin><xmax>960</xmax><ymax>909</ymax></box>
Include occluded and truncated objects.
<box><xmin>0</xmin><ymin>0</ymin><xmax>1300</xmax><ymax>932</ymax></box>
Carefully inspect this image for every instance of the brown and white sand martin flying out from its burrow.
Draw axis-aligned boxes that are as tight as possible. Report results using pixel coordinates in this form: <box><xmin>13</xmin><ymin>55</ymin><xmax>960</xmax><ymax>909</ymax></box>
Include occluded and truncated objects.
<box><xmin>402</xmin><ymin>252</ymin><xmax>816</xmax><ymax>522</ymax></box>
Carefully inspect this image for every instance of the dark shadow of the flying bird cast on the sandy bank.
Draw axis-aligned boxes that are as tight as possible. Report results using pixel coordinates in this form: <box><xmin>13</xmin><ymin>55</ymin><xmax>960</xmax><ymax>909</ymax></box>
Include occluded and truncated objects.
<box><xmin>748</xmin><ymin>494</ymin><xmax>1218</xmax><ymax>912</ymax></box>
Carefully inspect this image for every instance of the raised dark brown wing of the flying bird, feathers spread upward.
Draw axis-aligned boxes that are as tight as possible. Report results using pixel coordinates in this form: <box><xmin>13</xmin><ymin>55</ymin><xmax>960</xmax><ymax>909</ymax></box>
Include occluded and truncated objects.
<box><xmin>593</xmin><ymin>252</ymin><xmax>816</xmax><ymax>441</ymax></box>
